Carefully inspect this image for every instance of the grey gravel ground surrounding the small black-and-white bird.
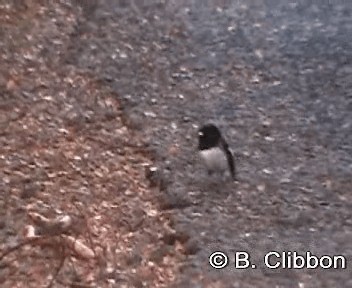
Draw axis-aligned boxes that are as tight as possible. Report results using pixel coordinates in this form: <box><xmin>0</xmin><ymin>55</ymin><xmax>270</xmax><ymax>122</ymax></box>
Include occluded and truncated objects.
<box><xmin>0</xmin><ymin>0</ymin><xmax>352</xmax><ymax>288</ymax></box>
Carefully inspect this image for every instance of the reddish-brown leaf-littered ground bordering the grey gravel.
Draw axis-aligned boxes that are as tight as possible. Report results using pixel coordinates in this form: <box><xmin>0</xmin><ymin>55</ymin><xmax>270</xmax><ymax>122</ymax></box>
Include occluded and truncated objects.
<box><xmin>0</xmin><ymin>3</ymin><xmax>183</xmax><ymax>287</ymax></box>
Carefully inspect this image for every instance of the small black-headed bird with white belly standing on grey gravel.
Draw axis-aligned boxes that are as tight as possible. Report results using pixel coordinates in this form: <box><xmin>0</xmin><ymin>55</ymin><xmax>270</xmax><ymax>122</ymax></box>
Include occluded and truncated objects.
<box><xmin>198</xmin><ymin>124</ymin><xmax>236</xmax><ymax>180</ymax></box>
